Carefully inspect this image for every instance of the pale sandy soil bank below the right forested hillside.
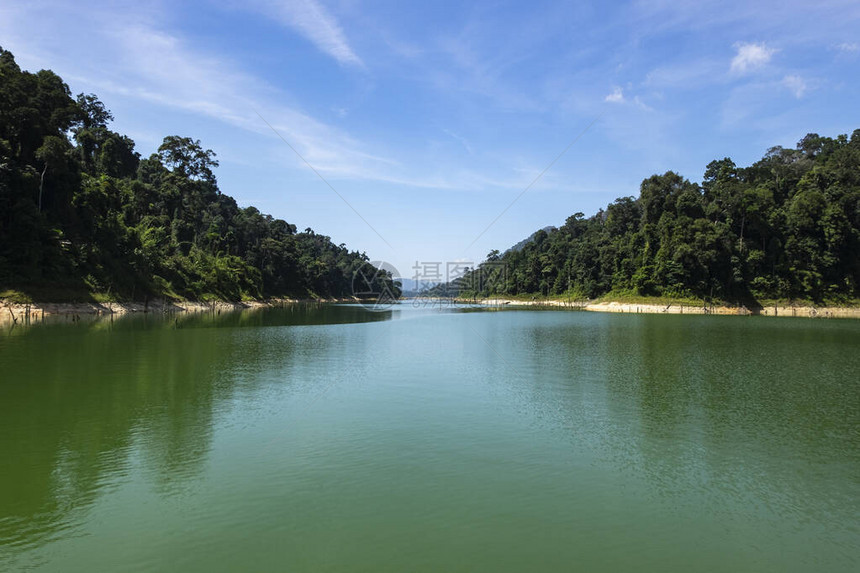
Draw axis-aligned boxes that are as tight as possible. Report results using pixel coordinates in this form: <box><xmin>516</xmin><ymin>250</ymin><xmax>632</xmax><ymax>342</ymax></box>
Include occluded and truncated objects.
<box><xmin>461</xmin><ymin>298</ymin><xmax>860</xmax><ymax>318</ymax></box>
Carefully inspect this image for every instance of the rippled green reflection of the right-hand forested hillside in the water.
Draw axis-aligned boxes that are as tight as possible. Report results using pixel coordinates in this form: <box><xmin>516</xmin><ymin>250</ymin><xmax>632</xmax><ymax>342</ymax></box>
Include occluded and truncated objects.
<box><xmin>510</xmin><ymin>313</ymin><xmax>860</xmax><ymax>551</ymax></box>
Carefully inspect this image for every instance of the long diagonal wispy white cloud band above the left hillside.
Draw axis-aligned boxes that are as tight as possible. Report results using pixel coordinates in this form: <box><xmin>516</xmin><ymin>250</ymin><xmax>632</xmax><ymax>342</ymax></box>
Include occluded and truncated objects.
<box><xmin>0</xmin><ymin>3</ymin><xmax>556</xmax><ymax>191</ymax></box>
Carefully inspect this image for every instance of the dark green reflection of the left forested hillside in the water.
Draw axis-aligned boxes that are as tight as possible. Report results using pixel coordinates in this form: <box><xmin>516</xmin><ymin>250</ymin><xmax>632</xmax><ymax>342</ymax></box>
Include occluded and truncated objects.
<box><xmin>0</xmin><ymin>305</ymin><xmax>391</xmax><ymax>568</ymax></box>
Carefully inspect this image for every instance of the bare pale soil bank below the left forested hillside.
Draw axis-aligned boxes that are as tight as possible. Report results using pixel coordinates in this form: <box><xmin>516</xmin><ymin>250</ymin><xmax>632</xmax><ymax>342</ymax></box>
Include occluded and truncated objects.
<box><xmin>0</xmin><ymin>299</ymin><xmax>355</xmax><ymax>324</ymax></box>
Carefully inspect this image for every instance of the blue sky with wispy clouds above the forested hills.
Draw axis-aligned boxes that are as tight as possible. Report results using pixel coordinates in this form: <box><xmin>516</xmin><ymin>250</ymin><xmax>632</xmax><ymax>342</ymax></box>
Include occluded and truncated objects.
<box><xmin>0</xmin><ymin>0</ymin><xmax>860</xmax><ymax>277</ymax></box>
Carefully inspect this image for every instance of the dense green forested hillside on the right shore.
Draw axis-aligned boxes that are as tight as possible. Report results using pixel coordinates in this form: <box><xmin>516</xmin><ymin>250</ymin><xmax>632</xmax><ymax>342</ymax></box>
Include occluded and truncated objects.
<box><xmin>462</xmin><ymin>130</ymin><xmax>860</xmax><ymax>304</ymax></box>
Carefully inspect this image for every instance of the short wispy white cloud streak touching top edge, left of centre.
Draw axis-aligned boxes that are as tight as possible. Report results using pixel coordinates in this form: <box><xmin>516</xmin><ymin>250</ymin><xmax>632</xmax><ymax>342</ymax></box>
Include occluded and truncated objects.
<box><xmin>255</xmin><ymin>0</ymin><xmax>364</xmax><ymax>66</ymax></box>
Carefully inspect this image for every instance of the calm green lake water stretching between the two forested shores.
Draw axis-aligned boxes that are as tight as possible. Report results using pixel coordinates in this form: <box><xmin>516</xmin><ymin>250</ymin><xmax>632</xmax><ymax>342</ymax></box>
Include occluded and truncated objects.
<box><xmin>0</xmin><ymin>305</ymin><xmax>860</xmax><ymax>572</ymax></box>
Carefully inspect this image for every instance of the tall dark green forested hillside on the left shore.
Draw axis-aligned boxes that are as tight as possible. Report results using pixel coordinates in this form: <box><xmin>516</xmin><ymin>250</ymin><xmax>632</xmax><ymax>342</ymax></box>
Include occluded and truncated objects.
<box><xmin>0</xmin><ymin>48</ymin><xmax>390</xmax><ymax>300</ymax></box>
